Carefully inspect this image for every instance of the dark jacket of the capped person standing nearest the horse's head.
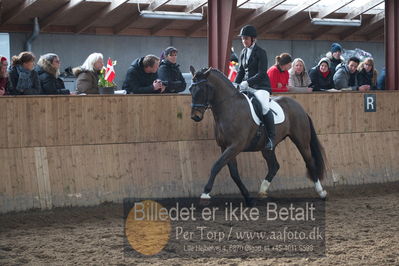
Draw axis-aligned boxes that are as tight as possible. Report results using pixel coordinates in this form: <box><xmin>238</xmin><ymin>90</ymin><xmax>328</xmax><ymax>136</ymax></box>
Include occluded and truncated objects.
<box><xmin>158</xmin><ymin>59</ymin><xmax>186</xmax><ymax>93</ymax></box>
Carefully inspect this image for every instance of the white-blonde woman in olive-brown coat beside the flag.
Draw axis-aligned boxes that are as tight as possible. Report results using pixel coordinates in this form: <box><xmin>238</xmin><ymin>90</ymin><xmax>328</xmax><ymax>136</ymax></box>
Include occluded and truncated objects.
<box><xmin>72</xmin><ymin>53</ymin><xmax>104</xmax><ymax>94</ymax></box>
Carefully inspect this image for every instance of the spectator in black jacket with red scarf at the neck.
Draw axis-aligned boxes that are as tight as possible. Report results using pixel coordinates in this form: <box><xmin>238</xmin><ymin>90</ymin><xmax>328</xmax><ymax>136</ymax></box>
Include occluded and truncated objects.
<box><xmin>309</xmin><ymin>57</ymin><xmax>334</xmax><ymax>91</ymax></box>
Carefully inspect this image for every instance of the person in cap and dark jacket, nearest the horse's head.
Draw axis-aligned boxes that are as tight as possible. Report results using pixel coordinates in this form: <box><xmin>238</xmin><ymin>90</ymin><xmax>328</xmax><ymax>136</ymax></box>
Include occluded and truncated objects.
<box><xmin>158</xmin><ymin>47</ymin><xmax>186</xmax><ymax>93</ymax></box>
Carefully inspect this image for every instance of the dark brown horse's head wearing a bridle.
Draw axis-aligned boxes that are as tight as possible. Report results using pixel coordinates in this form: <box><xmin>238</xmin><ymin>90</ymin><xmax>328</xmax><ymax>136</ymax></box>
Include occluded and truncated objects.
<box><xmin>190</xmin><ymin>66</ymin><xmax>212</xmax><ymax>122</ymax></box>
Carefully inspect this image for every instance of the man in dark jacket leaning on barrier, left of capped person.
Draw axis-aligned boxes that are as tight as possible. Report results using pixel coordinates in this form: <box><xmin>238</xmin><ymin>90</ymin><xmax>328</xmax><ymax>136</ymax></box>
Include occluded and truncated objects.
<box><xmin>123</xmin><ymin>55</ymin><xmax>166</xmax><ymax>94</ymax></box>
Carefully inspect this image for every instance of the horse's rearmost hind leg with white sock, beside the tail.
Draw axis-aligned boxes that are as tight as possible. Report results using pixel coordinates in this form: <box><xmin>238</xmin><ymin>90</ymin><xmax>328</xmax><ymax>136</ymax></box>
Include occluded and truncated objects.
<box><xmin>291</xmin><ymin>137</ymin><xmax>327</xmax><ymax>199</ymax></box>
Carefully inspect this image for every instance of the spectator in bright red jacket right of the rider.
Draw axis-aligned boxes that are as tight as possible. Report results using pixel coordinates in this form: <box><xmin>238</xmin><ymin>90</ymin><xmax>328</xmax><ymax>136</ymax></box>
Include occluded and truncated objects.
<box><xmin>267</xmin><ymin>53</ymin><xmax>292</xmax><ymax>92</ymax></box>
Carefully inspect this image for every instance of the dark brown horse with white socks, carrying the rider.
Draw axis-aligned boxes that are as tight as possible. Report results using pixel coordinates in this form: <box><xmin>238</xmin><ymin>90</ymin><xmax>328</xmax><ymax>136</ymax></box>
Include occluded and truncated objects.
<box><xmin>189</xmin><ymin>66</ymin><xmax>327</xmax><ymax>205</ymax></box>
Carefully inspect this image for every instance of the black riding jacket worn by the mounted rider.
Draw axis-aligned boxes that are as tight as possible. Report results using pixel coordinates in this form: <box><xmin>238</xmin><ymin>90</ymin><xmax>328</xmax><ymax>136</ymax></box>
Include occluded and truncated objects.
<box><xmin>235</xmin><ymin>44</ymin><xmax>271</xmax><ymax>92</ymax></box>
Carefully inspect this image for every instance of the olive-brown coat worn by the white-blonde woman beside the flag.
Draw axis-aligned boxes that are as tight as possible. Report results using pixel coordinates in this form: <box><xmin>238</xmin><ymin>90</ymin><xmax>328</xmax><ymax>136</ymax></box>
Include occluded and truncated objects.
<box><xmin>72</xmin><ymin>67</ymin><xmax>99</xmax><ymax>94</ymax></box>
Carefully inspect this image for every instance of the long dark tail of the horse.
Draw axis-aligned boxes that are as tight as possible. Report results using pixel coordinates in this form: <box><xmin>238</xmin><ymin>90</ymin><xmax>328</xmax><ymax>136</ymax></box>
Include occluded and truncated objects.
<box><xmin>308</xmin><ymin>115</ymin><xmax>326</xmax><ymax>180</ymax></box>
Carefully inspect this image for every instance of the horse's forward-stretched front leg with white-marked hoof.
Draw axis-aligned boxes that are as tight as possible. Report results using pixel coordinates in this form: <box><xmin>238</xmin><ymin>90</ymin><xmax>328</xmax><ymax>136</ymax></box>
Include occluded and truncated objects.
<box><xmin>201</xmin><ymin>146</ymin><xmax>241</xmax><ymax>199</ymax></box>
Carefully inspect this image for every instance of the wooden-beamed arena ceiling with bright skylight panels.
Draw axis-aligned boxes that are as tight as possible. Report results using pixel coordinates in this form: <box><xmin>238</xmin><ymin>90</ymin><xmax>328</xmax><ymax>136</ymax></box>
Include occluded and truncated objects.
<box><xmin>0</xmin><ymin>0</ymin><xmax>385</xmax><ymax>42</ymax></box>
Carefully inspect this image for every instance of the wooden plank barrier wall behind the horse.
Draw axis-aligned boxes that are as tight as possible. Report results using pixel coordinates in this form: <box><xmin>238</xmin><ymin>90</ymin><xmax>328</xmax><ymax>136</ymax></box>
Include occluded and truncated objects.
<box><xmin>0</xmin><ymin>91</ymin><xmax>399</xmax><ymax>212</ymax></box>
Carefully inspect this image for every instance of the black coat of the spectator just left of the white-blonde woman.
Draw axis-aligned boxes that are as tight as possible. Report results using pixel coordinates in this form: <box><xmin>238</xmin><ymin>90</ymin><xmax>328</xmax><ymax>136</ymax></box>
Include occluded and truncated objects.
<box><xmin>36</xmin><ymin>63</ymin><xmax>69</xmax><ymax>95</ymax></box>
